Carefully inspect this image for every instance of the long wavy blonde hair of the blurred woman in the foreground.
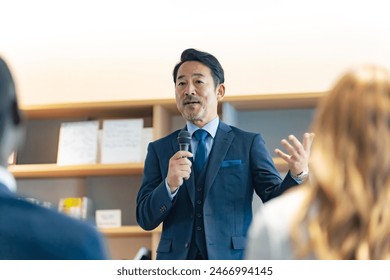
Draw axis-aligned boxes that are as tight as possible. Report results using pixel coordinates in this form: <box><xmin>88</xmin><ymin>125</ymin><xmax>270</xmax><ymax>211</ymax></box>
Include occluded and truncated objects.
<box><xmin>295</xmin><ymin>65</ymin><xmax>390</xmax><ymax>259</ymax></box>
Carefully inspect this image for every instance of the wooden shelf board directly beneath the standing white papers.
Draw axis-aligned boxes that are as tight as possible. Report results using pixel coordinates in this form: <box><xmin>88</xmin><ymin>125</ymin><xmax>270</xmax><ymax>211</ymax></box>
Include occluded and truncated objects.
<box><xmin>8</xmin><ymin>163</ymin><xmax>144</xmax><ymax>179</ymax></box>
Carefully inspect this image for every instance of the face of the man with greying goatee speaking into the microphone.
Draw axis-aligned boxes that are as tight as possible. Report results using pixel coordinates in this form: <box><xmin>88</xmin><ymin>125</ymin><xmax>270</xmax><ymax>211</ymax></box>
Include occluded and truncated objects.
<box><xmin>175</xmin><ymin>61</ymin><xmax>225</xmax><ymax>127</ymax></box>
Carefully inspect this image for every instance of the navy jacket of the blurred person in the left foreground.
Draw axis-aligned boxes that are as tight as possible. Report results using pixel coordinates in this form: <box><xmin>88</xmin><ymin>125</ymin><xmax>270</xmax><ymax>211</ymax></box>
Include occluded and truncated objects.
<box><xmin>0</xmin><ymin>183</ymin><xmax>107</xmax><ymax>260</ymax></box>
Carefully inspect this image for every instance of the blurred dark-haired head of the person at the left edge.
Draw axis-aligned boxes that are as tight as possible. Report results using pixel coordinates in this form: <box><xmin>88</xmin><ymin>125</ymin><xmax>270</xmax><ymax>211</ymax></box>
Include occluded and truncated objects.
<box><xmin>0</xmin><ymin>57</ymin><xmax>22</xmax><ymax>167</ymax></box>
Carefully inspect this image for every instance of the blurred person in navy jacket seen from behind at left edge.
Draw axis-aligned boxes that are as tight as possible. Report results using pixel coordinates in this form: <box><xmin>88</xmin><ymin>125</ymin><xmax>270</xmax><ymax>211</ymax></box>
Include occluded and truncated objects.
<box><xmin>0</xmin><ymin>58</ymin><xmax>107</xmax><ymax>260</ymax></box>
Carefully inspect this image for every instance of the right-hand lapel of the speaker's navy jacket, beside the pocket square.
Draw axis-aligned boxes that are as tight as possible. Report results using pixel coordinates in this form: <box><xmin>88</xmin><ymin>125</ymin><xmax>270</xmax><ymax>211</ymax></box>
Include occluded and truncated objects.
<box><xmin>204</xmin><ymin>121</ymin><xmax>234</xmax><ymax>197</ymax></box>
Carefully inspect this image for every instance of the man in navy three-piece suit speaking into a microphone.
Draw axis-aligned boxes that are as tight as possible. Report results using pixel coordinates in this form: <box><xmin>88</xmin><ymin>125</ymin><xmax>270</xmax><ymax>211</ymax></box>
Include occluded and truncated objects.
<box><xmin>137</xmin><ymin>49</ymin><xmax>314</xmax><ymax>260</ymax></box>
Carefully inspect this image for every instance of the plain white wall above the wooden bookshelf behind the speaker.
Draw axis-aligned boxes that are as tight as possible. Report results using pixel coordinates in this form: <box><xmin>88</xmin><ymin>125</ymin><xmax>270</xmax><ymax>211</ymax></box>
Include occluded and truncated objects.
<box><xmin>0</xmin><ymin>0</ymin><xmax>390</xmax><ymax>105</ymax></box>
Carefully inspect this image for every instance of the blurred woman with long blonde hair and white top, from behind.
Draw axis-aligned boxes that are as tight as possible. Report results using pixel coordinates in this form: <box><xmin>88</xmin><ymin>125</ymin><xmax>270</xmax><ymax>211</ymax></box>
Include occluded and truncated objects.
<box><xmin>246</xmin><ymin>65</ymin><xmax>390</xmax><ymax>259</ymax></box>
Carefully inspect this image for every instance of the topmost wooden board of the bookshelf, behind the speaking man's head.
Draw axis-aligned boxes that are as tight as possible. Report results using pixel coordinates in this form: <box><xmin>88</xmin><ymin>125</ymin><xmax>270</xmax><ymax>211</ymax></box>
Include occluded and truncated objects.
<box><xmin>21</xmin><ymin>92</ymin><xmax>327</xmax><ymax>119</ymax></box>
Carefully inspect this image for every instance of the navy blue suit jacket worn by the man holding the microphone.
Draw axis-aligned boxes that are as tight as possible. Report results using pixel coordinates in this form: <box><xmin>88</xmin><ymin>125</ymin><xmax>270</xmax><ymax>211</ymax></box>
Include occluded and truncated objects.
<box><xmin>137</xmin><ymin>122</ymin><xmax>297</xmax><ymax>259</ymax></box>
